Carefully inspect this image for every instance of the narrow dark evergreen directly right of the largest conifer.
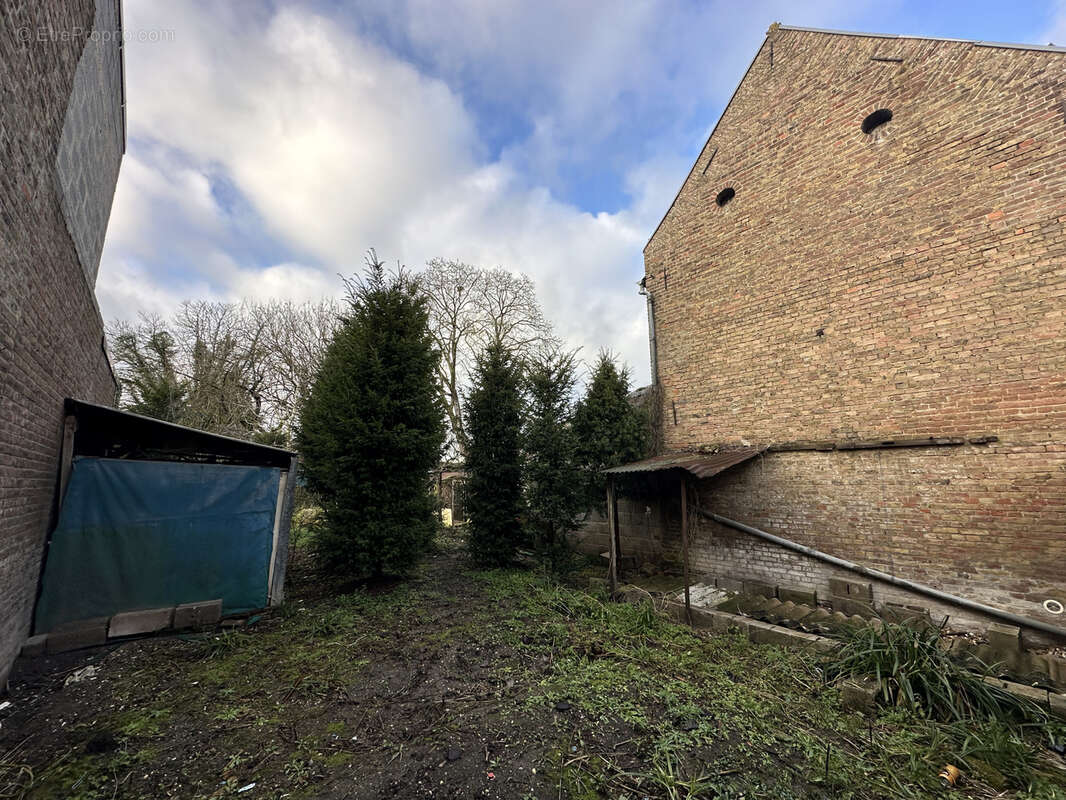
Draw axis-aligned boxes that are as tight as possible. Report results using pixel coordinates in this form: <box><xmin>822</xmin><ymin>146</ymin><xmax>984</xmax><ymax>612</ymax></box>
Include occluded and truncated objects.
<box><xmin>466</xmin><ymin>343</ymin><xmax>522</xmax><ymax>566</ymax></box>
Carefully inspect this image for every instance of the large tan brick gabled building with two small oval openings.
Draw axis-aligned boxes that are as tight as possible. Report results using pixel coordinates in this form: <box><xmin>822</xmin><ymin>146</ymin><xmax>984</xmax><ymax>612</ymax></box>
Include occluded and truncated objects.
<box><xmin>605</xmin><ymin>26</ymin><xmax>1066</xmax><ymax>627</ymax></box>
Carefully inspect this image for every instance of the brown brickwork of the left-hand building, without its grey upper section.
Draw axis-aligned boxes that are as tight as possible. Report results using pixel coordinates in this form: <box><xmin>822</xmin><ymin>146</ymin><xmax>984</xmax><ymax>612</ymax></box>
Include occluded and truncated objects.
<box><xmin>0</xmin><ymin>0</ymin><xmax>122</xmax><ymax>686</ymax></box>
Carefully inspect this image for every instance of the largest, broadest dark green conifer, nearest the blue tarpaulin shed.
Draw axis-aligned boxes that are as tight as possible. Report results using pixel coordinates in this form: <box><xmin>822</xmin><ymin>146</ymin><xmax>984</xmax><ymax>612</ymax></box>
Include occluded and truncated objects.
<box><xmin>297</xmin><ymin>251</ymin><xmax>445</xmax><ymax>577</ymax></box>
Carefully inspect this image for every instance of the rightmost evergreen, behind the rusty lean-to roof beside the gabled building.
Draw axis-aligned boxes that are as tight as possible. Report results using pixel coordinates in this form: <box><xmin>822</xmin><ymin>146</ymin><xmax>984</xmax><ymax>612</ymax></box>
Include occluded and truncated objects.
<box><xmin>574</xmin><ymin>352</ymin><xmax>648</xmax><ymax>509</ymax></box>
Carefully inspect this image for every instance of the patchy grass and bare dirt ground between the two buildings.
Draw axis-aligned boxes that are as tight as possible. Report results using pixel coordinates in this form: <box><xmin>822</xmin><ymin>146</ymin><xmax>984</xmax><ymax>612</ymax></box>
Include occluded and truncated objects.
<box><xmin>0</xmin><ymin>541</ymin><xmax>1066</xmax><ymax>800</ymax></box>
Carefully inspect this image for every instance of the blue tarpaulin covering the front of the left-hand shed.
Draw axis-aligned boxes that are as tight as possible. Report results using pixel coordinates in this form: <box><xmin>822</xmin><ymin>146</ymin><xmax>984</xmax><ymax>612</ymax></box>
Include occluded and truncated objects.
<box><xmin>35</xmin><ymin>458</ymin><xmax>281</xmax><ymax>633</ymax></box>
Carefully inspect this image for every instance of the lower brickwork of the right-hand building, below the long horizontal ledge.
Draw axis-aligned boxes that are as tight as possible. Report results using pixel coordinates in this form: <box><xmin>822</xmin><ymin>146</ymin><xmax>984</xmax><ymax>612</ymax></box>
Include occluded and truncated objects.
<box><xmin>577</xmin><ymin>445</ymin><xmax>1066</xmax><ymax>641</ymax></box>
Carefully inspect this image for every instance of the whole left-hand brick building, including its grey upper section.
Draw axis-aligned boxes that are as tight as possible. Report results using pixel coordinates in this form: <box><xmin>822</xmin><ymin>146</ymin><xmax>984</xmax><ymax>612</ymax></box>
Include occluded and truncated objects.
<box><xmin>0</xmin><ymin>0</ymin><xmax>126</xmax><ymax>688</ymax></box>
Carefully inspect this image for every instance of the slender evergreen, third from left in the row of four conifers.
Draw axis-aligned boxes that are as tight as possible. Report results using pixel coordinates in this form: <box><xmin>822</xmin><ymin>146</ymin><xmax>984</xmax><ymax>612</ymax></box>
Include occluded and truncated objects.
<box><xmin>522</xmin><ymin>351</ymin><xmax>583</xmax><ymax>571</ymax></box>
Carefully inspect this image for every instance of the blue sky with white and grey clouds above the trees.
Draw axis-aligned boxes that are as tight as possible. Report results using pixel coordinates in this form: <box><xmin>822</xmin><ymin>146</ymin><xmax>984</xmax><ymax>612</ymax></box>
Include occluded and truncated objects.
<box><xmin>97</xmin><ymin>0</ymin><xmax>1066</xmax><ymax>384</ymax></box>
